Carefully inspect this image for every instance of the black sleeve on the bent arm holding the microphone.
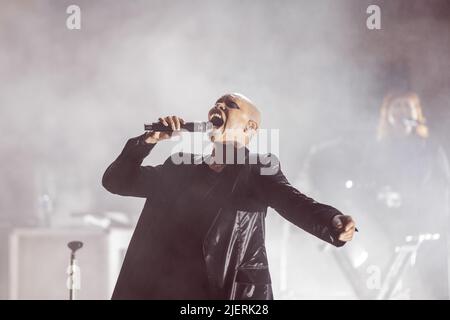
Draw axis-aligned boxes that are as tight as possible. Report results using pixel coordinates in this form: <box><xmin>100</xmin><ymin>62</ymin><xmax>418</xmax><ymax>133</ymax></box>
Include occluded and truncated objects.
<box><xmin>102</xmin><ymin>135</ymin><xmax>163</xmax><ymax>198</ymax></box>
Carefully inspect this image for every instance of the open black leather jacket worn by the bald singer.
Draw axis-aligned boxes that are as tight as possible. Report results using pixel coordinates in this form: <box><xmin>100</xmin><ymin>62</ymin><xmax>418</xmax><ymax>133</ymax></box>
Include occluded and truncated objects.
<box><xmin>102</xmin><ymin>136</ymin><xmax>344</xmax><ymax>299</ymax></box>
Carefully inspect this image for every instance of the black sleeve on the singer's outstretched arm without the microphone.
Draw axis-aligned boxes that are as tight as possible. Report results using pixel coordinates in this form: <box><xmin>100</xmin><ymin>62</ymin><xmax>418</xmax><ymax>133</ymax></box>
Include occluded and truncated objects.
<box><xmin>255</xmin><ymin>155</ymin><xmax>345</xmax><ymax>247</ymax></box>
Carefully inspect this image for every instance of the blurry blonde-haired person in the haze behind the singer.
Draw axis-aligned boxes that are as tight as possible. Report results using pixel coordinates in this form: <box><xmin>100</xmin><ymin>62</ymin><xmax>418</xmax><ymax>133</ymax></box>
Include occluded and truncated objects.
<box><xmin>362</xmin><ymin>91</ymin><xmax>450</xmax><ymax>299</ymax></box>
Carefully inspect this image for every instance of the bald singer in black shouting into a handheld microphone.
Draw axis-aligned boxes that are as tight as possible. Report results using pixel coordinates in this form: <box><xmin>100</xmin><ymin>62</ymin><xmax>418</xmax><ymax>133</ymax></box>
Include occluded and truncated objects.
<box><xmin>102</xmin><ymin>93</ymin><xmax>355</xmax><ymax>300</ymax></box>
